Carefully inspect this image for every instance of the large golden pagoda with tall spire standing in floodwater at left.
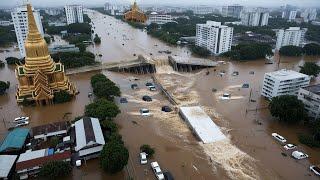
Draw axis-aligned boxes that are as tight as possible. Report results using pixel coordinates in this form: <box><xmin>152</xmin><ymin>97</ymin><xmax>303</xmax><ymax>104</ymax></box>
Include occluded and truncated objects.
<box><xmin>15</xmin><ymin>4</ymin><xmax>76</xmax><ymax>105</ymax></box>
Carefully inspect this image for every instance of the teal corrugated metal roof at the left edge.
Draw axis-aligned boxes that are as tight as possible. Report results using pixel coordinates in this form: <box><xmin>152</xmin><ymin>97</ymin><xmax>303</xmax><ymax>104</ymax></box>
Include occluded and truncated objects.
<box><xmin>0</xmin><ymin>128</ymin><xmax>29</xmax><ymax>152</ymax></box>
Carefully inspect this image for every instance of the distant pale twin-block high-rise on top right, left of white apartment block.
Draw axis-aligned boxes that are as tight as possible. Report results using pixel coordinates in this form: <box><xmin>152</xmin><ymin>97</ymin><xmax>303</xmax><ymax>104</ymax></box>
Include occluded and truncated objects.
<box><xmin>240</xmin><ymin>11</ymin><xmax>269</xmax><ymax>26</ymax></box>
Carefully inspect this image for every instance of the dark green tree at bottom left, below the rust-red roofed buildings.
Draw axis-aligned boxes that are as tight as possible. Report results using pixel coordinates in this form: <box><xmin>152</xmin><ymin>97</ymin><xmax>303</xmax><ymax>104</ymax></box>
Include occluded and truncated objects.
<box><xmin>39</xmin><ymin>161</ymin><xmax>72</xmax><ymax>179</ymax></box>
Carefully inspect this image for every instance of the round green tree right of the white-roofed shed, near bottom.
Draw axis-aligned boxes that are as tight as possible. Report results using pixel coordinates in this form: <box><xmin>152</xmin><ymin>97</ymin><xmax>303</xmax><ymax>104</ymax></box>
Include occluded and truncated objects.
<box><xmin>100</xmin><ymin>142</ymin><xmax>129</xmax><ymax>174</ymax></box>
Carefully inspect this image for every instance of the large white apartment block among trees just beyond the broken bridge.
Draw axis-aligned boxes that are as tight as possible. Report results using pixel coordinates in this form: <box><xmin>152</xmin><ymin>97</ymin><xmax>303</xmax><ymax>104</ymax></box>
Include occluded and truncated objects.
<box><xmin>196</xmin><ymin>21</ymin><xmax>233</xmax><ymax>55</ymax></box>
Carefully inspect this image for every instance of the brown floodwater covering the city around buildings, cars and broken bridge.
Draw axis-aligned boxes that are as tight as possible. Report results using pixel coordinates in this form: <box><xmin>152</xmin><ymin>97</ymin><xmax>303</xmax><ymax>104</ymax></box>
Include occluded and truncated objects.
<box><xmin>0</xmin><ymin>9</ymin><xmax>320</xmax><ymax>180</ymax></box>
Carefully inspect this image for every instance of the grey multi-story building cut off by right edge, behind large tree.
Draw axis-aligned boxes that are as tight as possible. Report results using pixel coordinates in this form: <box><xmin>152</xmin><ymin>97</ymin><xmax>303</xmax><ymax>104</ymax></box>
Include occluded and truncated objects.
<box><xmin>298</xmin><ymin>84</ymin><xmax>320</xmax><ymax>119</ymax></box>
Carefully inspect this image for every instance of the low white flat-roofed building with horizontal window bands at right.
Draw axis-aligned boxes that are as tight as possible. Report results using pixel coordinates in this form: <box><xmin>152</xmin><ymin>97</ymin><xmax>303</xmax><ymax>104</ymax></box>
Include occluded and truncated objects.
<box><xmin>261</xmin><ymin>69</ymin><xmax>310</xmax><ymax>99</ymax></box>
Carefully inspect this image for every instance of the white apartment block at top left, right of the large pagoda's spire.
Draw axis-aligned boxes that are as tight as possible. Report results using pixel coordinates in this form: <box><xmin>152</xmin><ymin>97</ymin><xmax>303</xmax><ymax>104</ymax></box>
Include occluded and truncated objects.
<box><xmin>64</xmin><ymin>5</ymin><xmax>83</xmax><ymax>24</ymax></box>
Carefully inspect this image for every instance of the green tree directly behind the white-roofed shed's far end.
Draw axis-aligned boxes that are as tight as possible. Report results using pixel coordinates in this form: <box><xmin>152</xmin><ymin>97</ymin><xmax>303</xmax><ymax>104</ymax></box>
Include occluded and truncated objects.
<box><xmin>85</xmin><ymin>99</ymin><xmax>120</xmax><ymax>120</ymax></box>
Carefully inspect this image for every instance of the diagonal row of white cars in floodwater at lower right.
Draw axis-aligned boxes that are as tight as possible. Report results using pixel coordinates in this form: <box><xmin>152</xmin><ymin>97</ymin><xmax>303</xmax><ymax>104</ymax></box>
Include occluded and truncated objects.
<box><xmin>271</xmin><ymin>133</ymin><xmax>320</xmax><ymax>176</ymax></box>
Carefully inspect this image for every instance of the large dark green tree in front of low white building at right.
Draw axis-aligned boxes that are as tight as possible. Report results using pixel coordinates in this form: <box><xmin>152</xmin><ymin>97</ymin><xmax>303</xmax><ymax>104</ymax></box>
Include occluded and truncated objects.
<box><xmin>269</xmin><ymin>95</ymin><xmax>307</xmax><ymax>123</ymax></box>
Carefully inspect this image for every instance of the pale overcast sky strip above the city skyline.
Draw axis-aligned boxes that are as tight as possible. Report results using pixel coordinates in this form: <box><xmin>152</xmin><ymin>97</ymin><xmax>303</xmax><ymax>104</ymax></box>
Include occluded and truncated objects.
<box><xmin>0</xmin><ymin>0</ymin><xmax>320</xmax><ymax>7</ymax></box>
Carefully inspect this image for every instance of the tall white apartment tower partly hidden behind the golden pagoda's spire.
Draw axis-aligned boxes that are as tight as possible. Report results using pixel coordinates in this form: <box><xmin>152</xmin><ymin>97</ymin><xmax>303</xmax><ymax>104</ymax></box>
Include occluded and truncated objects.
<box><xmin>11</xmin><ymin>5</ymin><xmax>44</xmax><ymax>57</ymax></box>
